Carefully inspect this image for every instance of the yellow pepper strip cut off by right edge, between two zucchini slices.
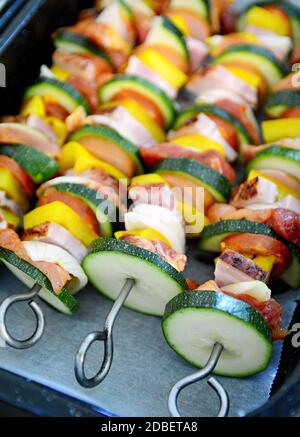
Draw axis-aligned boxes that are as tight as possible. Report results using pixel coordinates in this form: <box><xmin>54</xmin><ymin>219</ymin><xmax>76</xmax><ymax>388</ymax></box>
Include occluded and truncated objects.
<box><xmin>262</xmin><ymin>118</ymin><xmax>300</xmax><ymax>143</ymax></box>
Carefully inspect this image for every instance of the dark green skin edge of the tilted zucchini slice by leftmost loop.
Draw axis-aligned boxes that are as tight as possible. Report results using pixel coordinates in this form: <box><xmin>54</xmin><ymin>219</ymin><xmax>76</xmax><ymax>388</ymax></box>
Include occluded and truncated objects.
<box><xmin>0</xmin><ymin>248</ymin><xmax>79</xmax><ymax>315</ymax></box>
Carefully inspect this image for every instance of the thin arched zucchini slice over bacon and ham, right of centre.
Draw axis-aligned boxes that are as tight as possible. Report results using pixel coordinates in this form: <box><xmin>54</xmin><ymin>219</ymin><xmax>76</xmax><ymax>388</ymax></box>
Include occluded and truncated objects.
<box><xmin>173</xmin><ymin>105</ymin><xmax>251</xmax><ymax>144</ymax></box>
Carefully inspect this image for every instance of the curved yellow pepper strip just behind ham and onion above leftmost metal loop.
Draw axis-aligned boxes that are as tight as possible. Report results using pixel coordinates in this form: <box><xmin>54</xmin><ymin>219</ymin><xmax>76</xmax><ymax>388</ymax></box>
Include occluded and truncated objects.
<box><xmin>24</xmin><ymin>201</ymin><xmax>99</xmax><ymax>247</ymax></box>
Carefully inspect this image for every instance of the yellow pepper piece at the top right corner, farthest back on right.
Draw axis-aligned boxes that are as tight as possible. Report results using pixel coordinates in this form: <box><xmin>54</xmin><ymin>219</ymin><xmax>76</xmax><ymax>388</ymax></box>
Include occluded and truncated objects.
<box><xmin>245</xmin><ymin>6</ymin><xmax>291</xmax><ymax>36</ymax></box>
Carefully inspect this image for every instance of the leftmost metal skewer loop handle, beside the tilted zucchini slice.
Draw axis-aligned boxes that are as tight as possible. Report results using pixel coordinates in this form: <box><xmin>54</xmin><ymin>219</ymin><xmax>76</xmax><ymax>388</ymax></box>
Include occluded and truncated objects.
<box><xmin>0</xmin><ymin>284</ymin><xmax>45</xmax><ymax>349</ymax></box>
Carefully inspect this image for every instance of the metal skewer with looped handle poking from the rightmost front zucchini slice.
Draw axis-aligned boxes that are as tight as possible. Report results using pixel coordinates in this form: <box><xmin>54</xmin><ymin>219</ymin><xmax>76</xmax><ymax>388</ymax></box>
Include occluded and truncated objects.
<box><xmin>168</xmin><ymin>343</ymin><xmax>229</xmax><ymax>417</ymax></box>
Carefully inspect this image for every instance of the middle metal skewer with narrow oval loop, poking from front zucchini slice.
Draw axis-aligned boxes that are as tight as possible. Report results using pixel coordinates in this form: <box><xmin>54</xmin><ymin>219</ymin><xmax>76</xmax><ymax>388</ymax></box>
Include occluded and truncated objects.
<box><xmin>75</xmin><ymin>278</ymin><xmax>135</xmax><ymax>388</ymax></box>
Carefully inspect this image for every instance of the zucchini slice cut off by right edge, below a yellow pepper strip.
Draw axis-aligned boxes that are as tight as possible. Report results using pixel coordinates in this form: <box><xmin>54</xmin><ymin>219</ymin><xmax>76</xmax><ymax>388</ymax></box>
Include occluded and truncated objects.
<box><xmin>246</xmin><ymin>145</ymin><xmax>300</xmax><ymax>180</ymax></box>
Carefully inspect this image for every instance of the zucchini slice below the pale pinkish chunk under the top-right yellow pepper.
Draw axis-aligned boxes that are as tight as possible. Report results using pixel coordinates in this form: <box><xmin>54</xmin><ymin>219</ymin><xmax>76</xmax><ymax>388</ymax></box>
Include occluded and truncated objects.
<box><xmin>213</xmin><ymin>44</ymin><xmax>288</xmax><ymax>87</ymax></box>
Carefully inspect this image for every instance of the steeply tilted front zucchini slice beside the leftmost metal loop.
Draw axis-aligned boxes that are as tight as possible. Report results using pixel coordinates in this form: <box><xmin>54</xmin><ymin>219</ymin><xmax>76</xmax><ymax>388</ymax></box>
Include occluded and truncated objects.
<box><xmin>0</xmin><ymin>248</ymin><xmax>79</xmax><ymax>315</ymax></box>
